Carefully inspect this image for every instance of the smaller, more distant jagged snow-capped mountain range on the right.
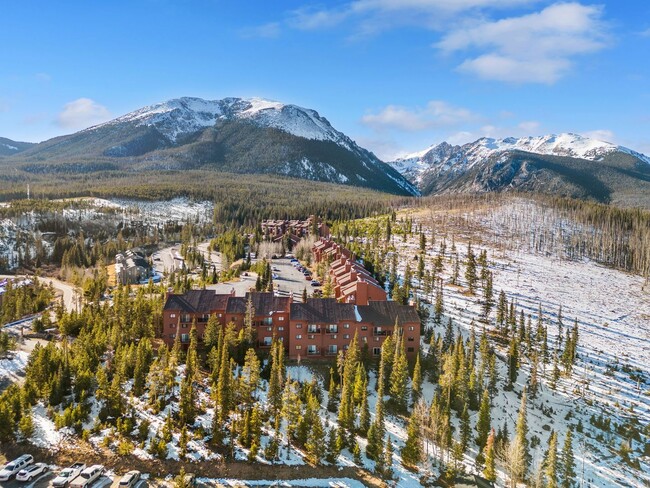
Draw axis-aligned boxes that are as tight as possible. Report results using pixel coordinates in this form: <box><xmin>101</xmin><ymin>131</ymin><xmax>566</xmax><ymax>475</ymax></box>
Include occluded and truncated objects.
<box><xmin>391</xmin><ymin>133</ymin><xmax>650</xmax><ymax>201</ymax></box>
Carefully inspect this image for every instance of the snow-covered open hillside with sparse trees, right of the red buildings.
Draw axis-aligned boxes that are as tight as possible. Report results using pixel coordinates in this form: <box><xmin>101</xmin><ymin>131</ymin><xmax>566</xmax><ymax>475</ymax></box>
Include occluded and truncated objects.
<box><xmin>380</xmin><ymin>211</ymin><xmax>650</xmax><ymax>487</ymax></box>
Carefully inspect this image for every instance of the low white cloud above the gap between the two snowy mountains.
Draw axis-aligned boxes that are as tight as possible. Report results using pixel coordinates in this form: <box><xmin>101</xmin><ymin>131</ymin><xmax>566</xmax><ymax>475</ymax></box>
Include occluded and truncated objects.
<box><xmin>361</xmin><ymin>100</ymin><xmax>479</xmax><ymax>132</ymax></box>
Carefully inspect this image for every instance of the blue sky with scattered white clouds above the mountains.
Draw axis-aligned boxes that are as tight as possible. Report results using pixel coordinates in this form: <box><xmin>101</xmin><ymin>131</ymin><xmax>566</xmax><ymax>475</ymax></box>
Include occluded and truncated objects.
<box><xmin>0</xmin><ymin>0</ymin><xmax>650</xmax><ymax>158</ymax></box>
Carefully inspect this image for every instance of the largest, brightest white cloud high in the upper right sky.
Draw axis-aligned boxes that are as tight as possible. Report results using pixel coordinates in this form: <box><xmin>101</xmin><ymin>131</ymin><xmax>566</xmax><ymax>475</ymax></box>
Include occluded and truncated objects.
<box><xmin>435</xmin><ymin>2</ymin><xmax>606</xmax><ymax>84</ymax></box>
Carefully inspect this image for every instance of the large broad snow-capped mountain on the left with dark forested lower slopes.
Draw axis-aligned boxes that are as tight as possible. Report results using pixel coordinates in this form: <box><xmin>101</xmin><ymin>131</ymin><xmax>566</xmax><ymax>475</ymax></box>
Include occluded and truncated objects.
<box><xmin>8</xmin><ymin>97</ymin><xmax>418</xmax><ymax>195</ymax></box>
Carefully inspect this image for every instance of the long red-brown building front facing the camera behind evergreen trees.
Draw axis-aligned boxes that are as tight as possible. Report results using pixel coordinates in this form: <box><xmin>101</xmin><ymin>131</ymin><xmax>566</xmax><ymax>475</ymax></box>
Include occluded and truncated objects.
<box><xmin>162</xmin><ymin>290</ymin><xmax>420</xmax><ymax>359</ymax></box>
